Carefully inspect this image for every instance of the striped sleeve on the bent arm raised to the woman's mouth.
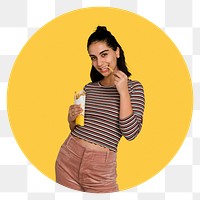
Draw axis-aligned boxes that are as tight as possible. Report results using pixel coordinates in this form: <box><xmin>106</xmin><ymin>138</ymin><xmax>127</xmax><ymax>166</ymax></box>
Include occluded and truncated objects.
<box><xmin>119</xmin><ymin>81</ymin><xmax>145</xmax><ymax>140</ymax></box>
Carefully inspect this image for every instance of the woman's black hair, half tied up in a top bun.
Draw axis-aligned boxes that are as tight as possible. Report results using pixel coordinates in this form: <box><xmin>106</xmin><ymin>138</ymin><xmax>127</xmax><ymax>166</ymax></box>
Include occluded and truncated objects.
<box><xmin>87</xmin><ymin>26</ymin><xmax>131</xmax><ymax>82</ymax></box>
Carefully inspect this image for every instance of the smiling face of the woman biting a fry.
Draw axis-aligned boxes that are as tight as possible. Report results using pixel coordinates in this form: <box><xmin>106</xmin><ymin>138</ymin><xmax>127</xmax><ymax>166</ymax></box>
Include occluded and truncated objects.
<box><xmin>88</xmin><ymin>41</ymin><xmax>119</xmax><ymax>77</ymax></box>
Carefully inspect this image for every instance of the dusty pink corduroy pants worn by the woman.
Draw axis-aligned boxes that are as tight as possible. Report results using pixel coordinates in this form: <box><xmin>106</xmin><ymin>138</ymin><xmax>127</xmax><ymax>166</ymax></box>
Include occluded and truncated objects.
<box><xmin>55</xmin><ymin>135</ymin><xmax>118</xmax><ymax>193</ymax></box>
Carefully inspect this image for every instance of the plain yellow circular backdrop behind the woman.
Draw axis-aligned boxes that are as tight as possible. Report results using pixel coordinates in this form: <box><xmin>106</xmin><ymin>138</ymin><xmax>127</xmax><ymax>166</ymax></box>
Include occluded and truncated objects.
<box><xmin>7</xmin><ymin>7</ymin><xmax>193</xmax><ymax>190</ymax></box>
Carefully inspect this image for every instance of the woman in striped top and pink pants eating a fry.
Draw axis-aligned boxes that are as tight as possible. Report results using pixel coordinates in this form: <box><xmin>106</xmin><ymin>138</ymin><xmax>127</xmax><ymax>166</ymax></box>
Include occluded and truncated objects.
<box><xmin>56</xmin><ymin>26</ymin><xmax>144</xmax><ymax>193</ymax></box>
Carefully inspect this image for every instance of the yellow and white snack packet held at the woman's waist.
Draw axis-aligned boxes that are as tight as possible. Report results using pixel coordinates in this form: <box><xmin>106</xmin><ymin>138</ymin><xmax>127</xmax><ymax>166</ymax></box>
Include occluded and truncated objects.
<box><xmin>74</xmin><ymin>90</ymin><xmax>86</xmax><ymax>126</ymax></box>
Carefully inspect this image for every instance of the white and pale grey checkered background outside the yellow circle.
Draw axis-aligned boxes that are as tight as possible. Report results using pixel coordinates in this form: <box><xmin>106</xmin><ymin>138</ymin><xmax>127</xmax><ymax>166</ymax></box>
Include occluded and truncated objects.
<box><xmin>0</xmin><ymin>0</ymin><xmax>200</xmax><ymax>200</ymax></box>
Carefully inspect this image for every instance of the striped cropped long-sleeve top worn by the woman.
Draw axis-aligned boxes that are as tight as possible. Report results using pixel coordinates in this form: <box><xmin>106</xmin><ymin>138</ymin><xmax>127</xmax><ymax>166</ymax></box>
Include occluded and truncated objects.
<box><xmin>71</xmin><ymin>79</ymin><xmax>145</xmax><ymax>152</ymax></box>
